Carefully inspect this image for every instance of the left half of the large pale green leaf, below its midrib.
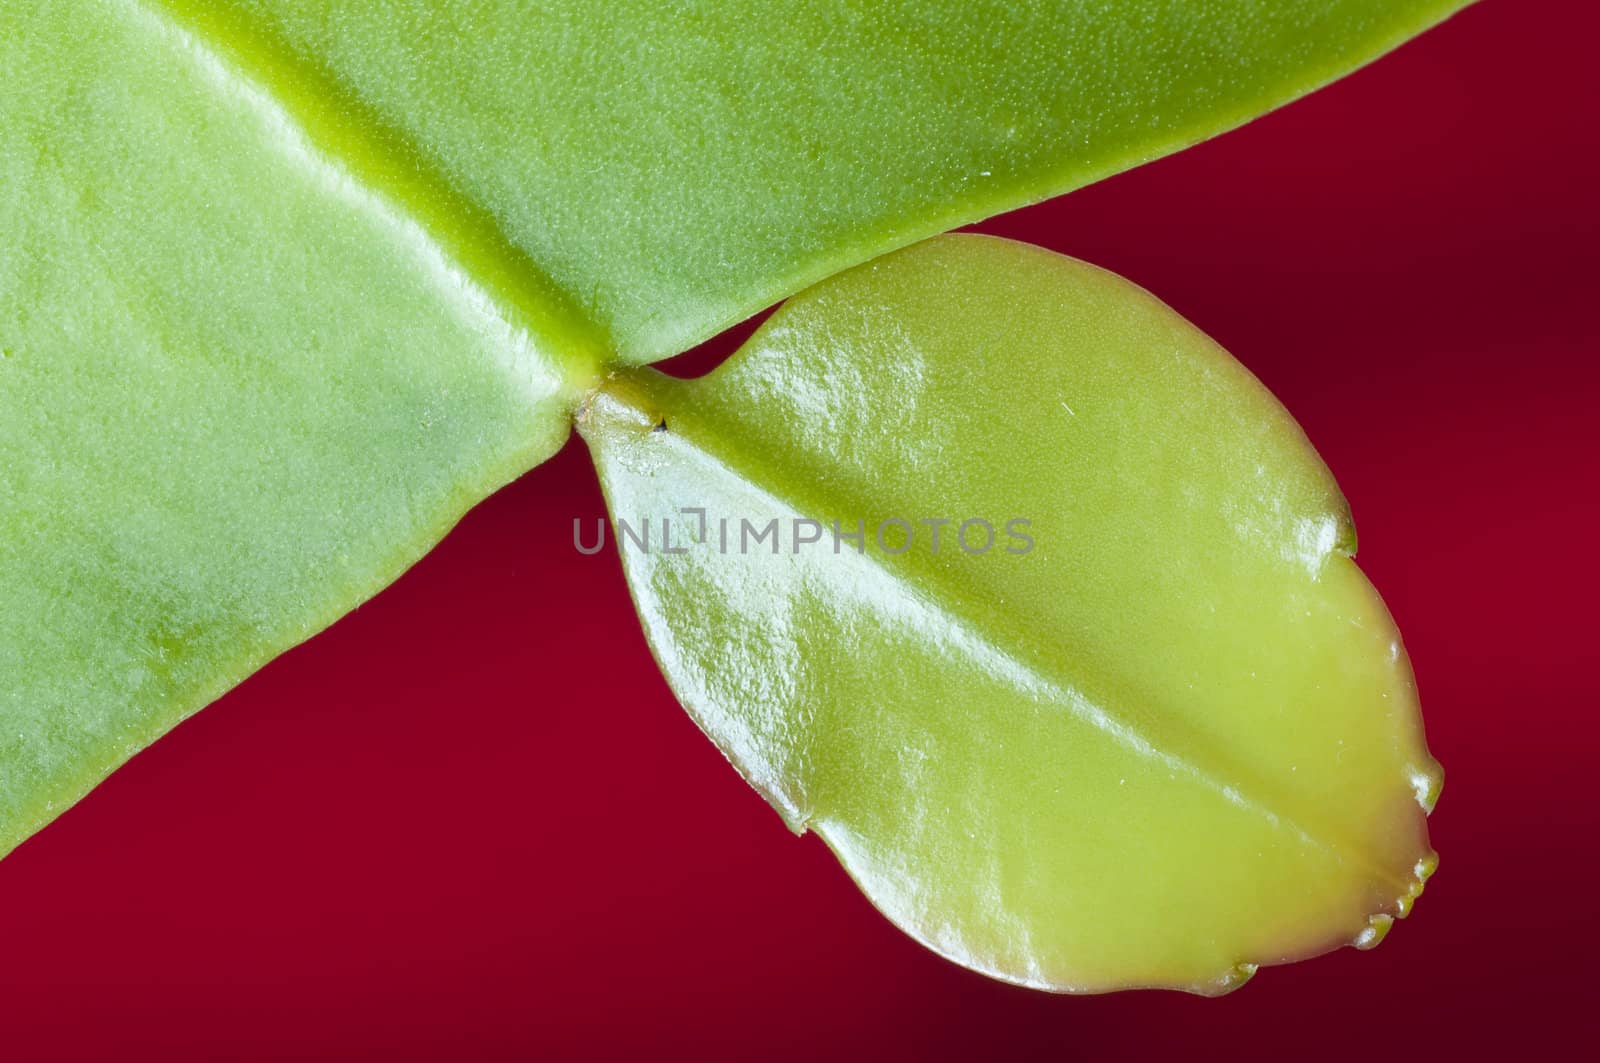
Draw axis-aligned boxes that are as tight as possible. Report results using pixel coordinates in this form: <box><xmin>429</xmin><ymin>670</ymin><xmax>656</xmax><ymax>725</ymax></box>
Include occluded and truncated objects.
<box><xmin>0</xmin><ymin>2</ymin><xmax>585</xmax><ymax>853</ymax></box>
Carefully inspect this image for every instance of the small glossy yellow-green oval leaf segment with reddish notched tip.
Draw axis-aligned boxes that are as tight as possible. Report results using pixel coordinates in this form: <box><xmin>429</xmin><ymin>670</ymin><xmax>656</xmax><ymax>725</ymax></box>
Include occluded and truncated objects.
<box><xmin>579</xmin><ymin>237</ymin><xmax>1440</xmax><ymax>993</ymax></box>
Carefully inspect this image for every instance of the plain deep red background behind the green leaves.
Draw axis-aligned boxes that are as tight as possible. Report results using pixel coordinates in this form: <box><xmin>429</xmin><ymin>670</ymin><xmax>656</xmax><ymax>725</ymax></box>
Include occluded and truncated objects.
<box><xmin>0</xmin><ymin>0</ymin><xmax>1600</xmax><ymax>1060</ymax></box>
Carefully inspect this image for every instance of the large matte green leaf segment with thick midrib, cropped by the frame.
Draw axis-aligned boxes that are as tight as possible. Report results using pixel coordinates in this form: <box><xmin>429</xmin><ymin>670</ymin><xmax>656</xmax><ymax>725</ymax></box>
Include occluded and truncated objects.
<box><xmin>0</xmin><ymin>0</ymin><xmax>1461</xmax><ymax>877</ymax></box>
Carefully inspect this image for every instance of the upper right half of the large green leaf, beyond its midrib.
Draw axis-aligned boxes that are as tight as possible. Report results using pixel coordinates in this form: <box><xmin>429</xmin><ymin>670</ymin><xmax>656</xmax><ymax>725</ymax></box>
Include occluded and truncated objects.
<box><xmin>144</xmin><ymin>0</ymin><xmax>1466</xmax><ymax>363</ymax></box>
